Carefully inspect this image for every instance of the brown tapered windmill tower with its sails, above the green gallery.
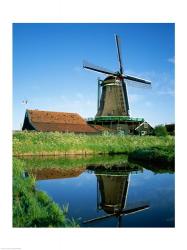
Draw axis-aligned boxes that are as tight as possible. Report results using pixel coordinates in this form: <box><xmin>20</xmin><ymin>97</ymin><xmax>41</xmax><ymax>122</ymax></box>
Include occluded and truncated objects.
<box><xmin>83</xmin><ymin>35</ymin><xmax>151</xmax><ymax>117</ymax></box>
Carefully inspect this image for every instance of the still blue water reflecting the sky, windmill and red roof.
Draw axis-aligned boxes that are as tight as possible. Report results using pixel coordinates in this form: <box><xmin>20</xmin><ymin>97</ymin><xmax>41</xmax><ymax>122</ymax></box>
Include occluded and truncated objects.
<box><xmin>30</xmin><ymin>156</ymin><xmax>175</xmax><ymax>227</ymax></box>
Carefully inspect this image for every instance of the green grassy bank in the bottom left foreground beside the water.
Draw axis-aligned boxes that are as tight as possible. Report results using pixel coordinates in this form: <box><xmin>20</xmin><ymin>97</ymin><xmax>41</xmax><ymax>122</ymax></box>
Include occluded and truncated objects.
<box><xmin>13</xmin><ymin>159</ymin><xmax>77</xmax><ymax>227</ymax></box>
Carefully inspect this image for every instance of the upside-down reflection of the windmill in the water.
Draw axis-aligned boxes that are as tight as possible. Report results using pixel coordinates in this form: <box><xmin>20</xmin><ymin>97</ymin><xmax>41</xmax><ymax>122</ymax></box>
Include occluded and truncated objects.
<box><xmin>83</xmin><ymin>165</ymin><xmax>150</xmax><ymax>227</ymax></box>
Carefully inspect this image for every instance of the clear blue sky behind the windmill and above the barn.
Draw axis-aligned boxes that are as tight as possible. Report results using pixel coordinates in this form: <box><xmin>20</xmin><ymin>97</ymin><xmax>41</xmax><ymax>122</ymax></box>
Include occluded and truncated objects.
<box><xmin>13</xmin><ymin>23</ymin><xmax>175</xmax><ymax>129</ymax></box>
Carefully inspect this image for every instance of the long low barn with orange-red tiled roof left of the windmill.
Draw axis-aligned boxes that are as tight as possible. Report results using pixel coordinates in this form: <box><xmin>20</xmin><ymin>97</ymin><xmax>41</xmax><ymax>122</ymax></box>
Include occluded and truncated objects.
<box><xmin>22</xmin><ymin>110</ymin><xmax>110</xmax><ymax>134</ymax></box>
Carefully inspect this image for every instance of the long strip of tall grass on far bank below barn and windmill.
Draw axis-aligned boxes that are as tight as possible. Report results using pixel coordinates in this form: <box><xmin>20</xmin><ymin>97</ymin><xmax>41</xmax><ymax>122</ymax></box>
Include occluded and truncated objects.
<box><xmin>13</xmin><ymin>132</ymin><xmax>174</xmax><ymax>156</ymax></box>
